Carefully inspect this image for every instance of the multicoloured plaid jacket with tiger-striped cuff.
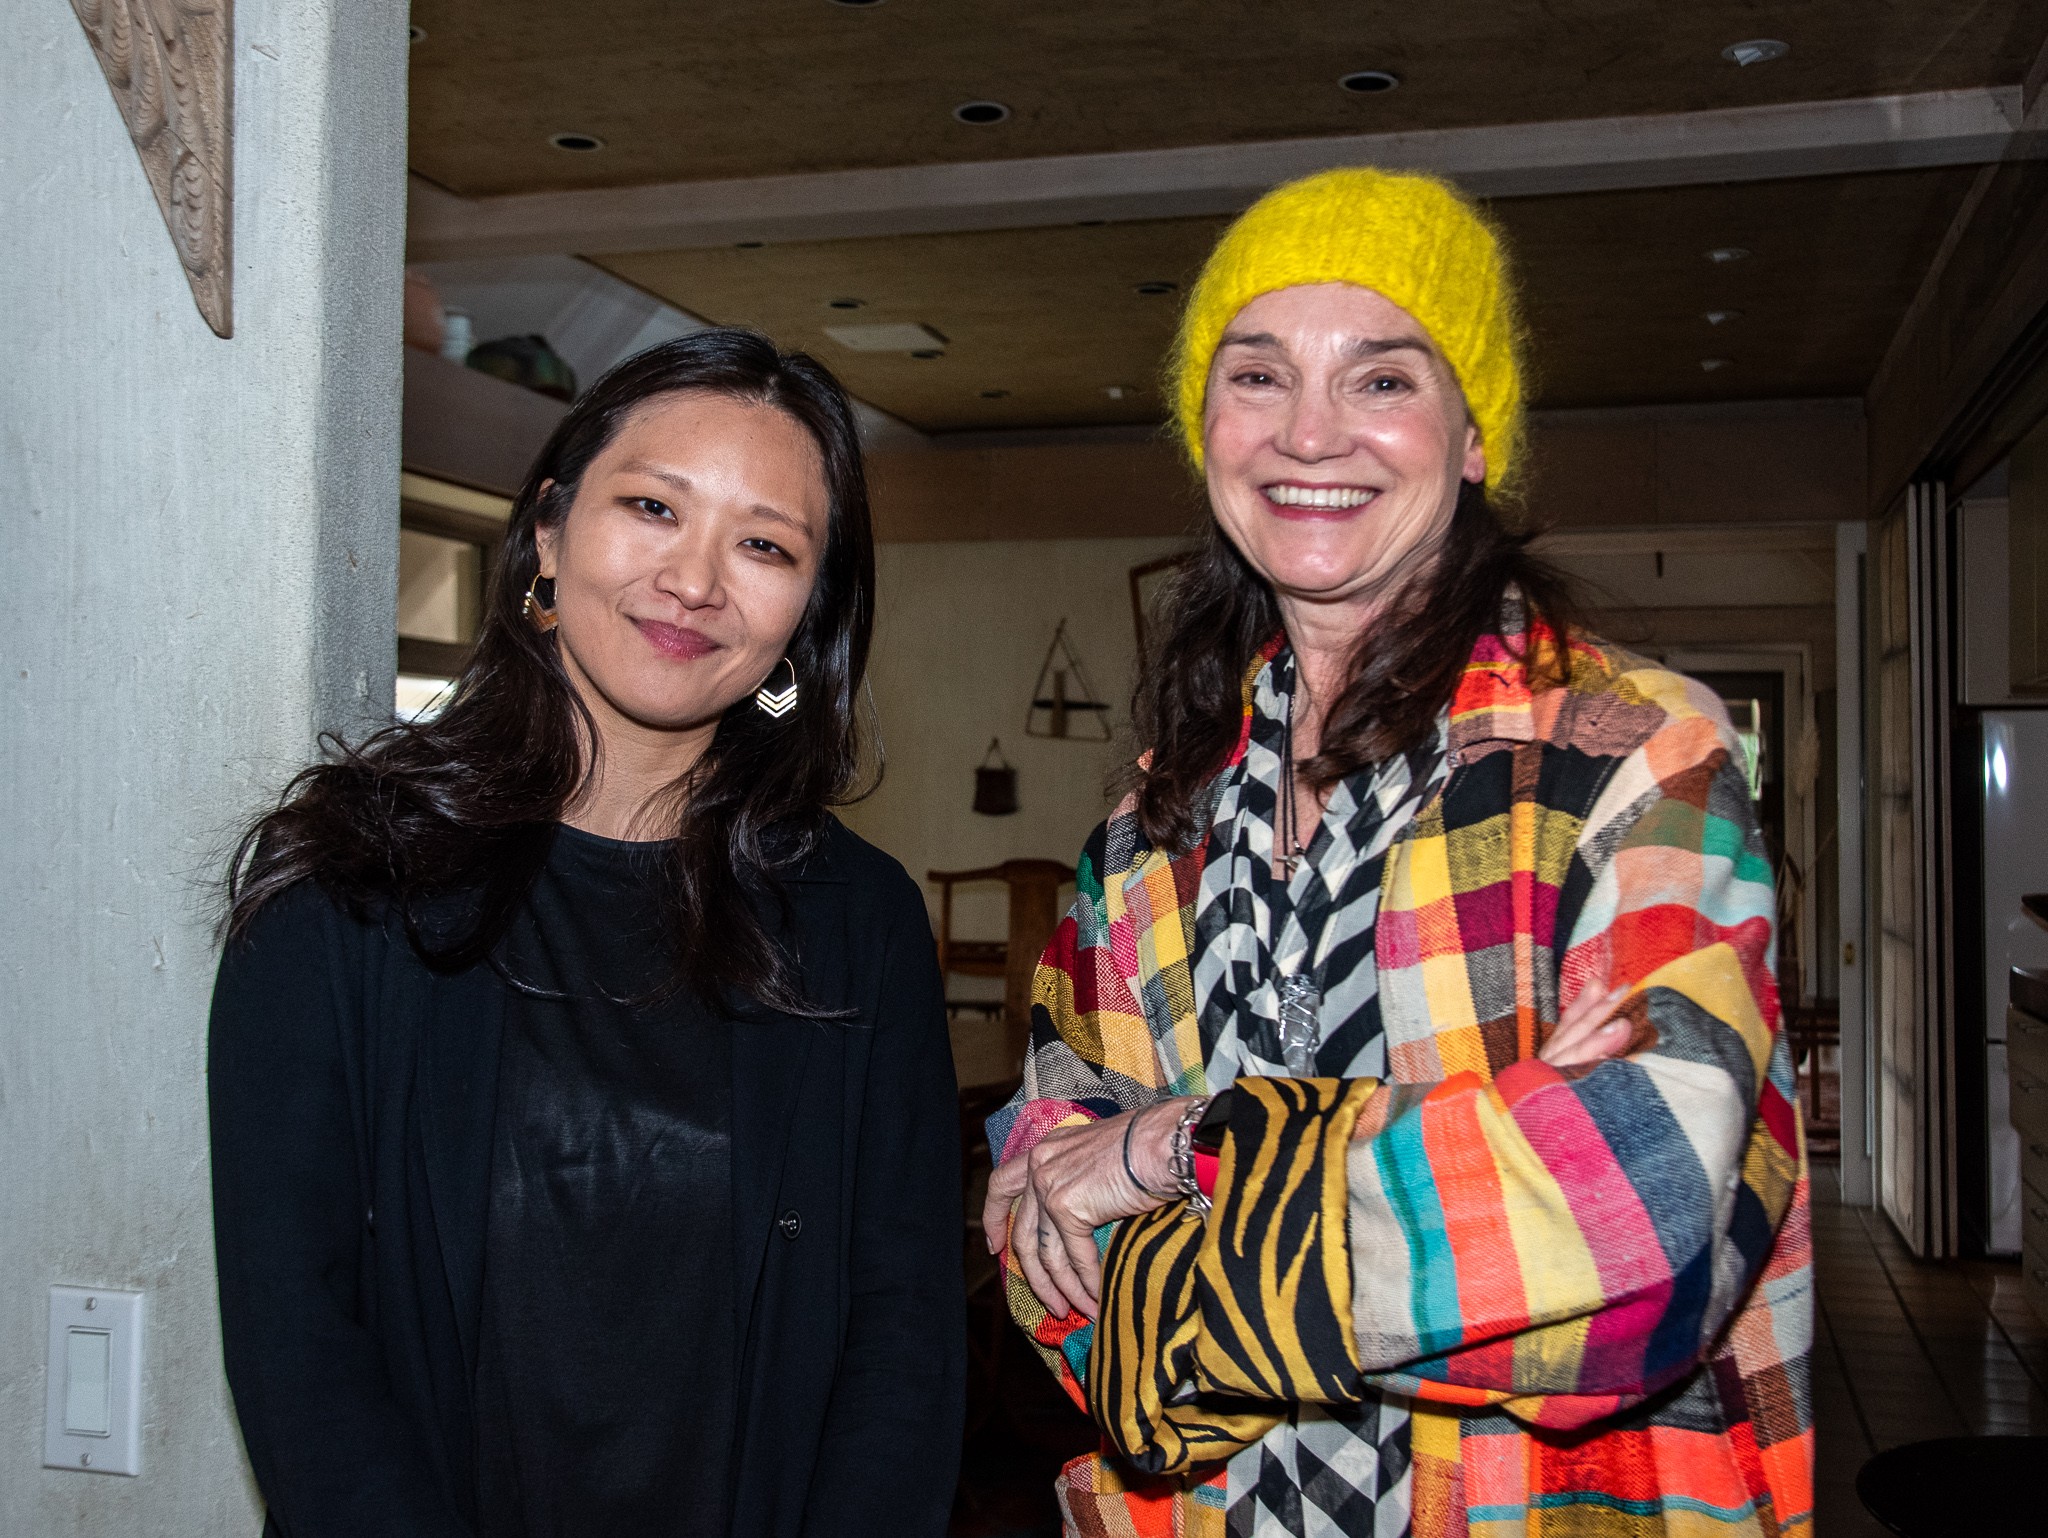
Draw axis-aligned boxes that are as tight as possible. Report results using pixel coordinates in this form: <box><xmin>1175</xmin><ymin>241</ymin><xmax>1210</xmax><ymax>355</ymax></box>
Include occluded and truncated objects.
<box><xmin>989</xmin><ymin>635</ymin><xmax>1812</xmax><ymax>1538</ymax></box>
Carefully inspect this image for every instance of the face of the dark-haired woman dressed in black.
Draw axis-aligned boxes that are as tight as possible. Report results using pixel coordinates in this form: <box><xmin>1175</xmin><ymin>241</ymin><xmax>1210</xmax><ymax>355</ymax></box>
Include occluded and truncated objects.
<box><xmin>537</xmin><ymin>393</ymin><xmax>829</xmax><ymax>752</ymax></box>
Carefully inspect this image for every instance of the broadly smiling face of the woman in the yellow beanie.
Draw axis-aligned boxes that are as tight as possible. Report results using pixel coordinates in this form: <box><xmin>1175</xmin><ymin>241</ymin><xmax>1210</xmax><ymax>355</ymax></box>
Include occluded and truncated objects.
<box><xmin>1202</xmin><ymin>283</ymin><xmax>1487</xmax><ymax>626</ymax></box>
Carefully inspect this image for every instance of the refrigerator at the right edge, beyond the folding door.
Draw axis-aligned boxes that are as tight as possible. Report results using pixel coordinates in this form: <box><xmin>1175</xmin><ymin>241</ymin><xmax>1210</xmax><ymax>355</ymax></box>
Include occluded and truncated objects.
<box><xmin>1958</xmin><ymin>711</ymin><xmax>2048</xmax><ymax>1255</ymax></box>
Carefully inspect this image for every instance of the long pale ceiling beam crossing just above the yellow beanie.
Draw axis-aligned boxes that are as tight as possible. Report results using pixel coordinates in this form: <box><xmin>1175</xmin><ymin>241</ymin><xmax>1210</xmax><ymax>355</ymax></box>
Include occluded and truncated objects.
<box><xmin>408</xmin><ymin>86</ymin><xmax>2021</xmax><ymax>262</ymax></box>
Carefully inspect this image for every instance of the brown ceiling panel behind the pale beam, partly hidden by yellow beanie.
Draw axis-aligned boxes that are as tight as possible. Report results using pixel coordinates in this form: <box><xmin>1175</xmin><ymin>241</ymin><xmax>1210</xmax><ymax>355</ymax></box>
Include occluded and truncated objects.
<box><xmin>594</xmin><ymin>170</ymin><xmax>1972</xmax><ymax>432</ymax></box>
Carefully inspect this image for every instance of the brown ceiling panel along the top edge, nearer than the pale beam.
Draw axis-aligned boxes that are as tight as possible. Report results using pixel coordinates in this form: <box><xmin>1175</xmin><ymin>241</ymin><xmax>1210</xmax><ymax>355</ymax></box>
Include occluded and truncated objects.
<box><xmin>412</xmin><ymin>0</ymin><xmax>2048</xmax><ymax>197</ymax></box>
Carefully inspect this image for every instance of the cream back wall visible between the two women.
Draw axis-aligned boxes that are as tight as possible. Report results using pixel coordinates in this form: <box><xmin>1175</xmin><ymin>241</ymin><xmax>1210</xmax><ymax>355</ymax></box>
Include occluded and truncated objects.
<box><xmin>842</xmin><ymin>539</ymin><xmax>1184</xmax><ymax>950</ymax></box>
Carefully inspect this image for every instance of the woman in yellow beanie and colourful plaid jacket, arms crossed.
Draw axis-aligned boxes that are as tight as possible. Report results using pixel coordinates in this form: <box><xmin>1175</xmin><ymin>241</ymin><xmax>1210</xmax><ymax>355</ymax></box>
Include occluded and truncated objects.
<box><xmin>985</xmin><ymin>170</ymin><xmax>1812</xmax><ymax>1538</ymax></box>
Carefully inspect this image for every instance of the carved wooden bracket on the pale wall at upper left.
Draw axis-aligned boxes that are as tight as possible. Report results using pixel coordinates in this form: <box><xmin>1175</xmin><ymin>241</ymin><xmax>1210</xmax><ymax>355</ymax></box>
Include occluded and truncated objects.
<box><xmin>72</xmin><ymin>0</ymin><xmax>236</xmax><ymax>336</ymax></box>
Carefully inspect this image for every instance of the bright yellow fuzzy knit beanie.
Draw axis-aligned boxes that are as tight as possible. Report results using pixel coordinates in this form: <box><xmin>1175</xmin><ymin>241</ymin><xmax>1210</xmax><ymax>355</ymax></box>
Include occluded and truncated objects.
<box><xmin>1169</xmin><ymin>168</ymin><xmax>1522</xmax><ymax>489</ymax></box>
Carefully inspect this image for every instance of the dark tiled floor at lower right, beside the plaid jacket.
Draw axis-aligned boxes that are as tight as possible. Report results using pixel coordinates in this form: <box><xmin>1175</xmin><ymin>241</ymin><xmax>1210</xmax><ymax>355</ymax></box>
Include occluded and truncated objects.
<box><xmin>1812</xmin><ymin>1161</ymin><xmax>2048</xmax><ymax>1538</ymax></box>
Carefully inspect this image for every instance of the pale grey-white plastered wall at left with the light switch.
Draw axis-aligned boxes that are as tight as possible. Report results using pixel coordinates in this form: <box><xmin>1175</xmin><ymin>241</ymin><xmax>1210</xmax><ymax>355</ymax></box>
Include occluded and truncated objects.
<box><xmin>0</xmin><ymin>0</ymin><xmax>406</xmax><ymax>1538</ymax></box>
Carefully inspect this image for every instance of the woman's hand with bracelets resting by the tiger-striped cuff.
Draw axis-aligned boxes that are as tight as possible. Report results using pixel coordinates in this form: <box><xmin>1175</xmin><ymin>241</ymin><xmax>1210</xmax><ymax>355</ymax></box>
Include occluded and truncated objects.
<box><xmin>981</xmin><ymin>1100</ymin><xmax>1182</xmax><ymax>1319</ymax></box>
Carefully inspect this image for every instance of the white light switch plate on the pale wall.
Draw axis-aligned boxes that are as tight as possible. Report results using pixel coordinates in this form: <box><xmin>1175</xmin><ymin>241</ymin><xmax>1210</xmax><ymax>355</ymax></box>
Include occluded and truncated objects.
<box><xmin>43</xmin><ymin>1286</ymin><xmax>143</xmax><ymax>1475</ymax></box>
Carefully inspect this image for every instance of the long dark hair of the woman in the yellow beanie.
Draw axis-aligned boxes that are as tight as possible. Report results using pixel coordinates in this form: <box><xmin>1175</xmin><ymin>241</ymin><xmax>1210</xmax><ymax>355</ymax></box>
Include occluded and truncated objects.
<box><xmin>1137</xmin><ymin>481</ymin><xmax>1575</xmax><ymax>850</ymax></box>
